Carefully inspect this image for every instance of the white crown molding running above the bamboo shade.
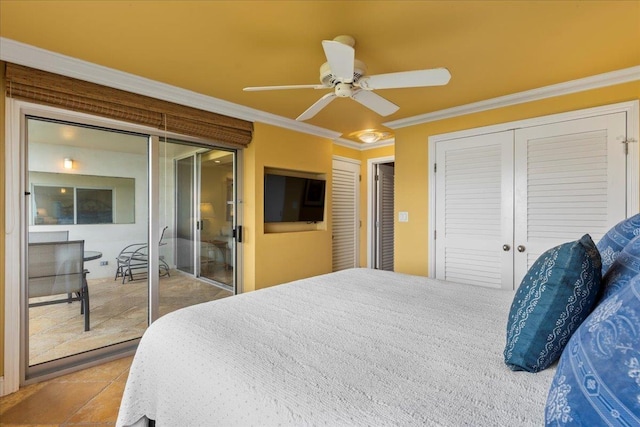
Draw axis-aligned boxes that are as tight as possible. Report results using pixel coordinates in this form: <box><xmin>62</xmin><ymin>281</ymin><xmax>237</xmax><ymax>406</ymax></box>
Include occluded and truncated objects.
<box><xmin>0</xmin><ymin>37</ymin><xmax>342</xmax><ymax>140</ymax></box>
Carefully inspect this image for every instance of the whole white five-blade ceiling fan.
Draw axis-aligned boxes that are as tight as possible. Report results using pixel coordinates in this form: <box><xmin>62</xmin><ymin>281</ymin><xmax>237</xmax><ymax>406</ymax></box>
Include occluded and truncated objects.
<box><xmin>243</xmin><ymin>36</ymin><xmax>451</xmax><ymax>120</ymax></box>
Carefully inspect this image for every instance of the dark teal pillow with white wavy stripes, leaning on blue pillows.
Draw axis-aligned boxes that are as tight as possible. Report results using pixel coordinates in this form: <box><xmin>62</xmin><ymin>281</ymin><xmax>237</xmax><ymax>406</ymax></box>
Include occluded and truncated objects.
<box><xmin>504</xmin><ymin>234</ymin><xmax>602</xmax><ymax>372</ymax></box>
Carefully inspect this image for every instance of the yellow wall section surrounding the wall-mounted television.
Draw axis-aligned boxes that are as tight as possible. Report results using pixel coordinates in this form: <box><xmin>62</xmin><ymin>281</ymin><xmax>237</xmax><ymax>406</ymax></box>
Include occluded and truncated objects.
<box><xmin>243</xmin><ymin>123</ymin><xmax>333</xmax><ymax>291</ymax></box>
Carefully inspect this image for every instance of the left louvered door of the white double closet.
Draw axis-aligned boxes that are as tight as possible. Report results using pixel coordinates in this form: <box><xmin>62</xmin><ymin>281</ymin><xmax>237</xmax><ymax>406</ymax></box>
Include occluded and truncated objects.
<box><xmin>435</xmin><ymin>131</ymin><xmax>513</xmax><ymax>289</ymax></box>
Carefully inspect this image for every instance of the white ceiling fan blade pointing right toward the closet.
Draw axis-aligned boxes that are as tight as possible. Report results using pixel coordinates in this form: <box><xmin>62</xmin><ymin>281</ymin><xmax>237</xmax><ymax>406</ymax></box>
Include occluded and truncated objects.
<box><xmin>358</xmin><ymin>68</ymin><xmax>451</xmax><ymax>90</ymax></box>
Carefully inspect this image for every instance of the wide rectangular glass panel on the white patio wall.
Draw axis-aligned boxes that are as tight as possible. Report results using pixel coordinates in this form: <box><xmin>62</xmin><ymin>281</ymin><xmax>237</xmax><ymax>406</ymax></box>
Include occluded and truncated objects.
<box><xmin>29</xmin><ymin>172</ymin><xmax>135</xmax><ymax>225</ymax></box>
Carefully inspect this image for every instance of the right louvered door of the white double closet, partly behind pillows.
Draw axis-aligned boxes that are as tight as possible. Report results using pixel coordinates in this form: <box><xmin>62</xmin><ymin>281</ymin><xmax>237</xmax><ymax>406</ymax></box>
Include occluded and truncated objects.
<box><xmin>514</xmin><ymin>113</ymin><xmax>626</xmax><ymax>287</ymax></box>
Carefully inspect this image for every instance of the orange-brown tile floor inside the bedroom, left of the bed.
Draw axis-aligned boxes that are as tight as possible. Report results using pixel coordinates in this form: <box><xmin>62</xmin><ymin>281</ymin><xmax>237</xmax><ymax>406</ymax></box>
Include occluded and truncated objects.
<box><xmin>0</xmin><ymin>356</ymin><xmax>133</xmax><ymax>427</ymax></box>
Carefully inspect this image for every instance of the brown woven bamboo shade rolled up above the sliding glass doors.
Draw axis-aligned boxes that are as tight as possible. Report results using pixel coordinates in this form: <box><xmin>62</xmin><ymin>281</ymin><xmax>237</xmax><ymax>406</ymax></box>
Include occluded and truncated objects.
<box><xmin>5</xmin><ymin>63</ymin><xmax>253</xmax><ymax>148</ymax></box>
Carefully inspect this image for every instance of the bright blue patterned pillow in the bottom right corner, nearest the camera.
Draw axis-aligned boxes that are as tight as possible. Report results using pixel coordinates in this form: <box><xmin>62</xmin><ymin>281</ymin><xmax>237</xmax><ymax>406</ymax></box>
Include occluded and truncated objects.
<box><xmin>545</xmin><ymin>276</ymin><xmax>640</xmax><ymax>426</ymax></box>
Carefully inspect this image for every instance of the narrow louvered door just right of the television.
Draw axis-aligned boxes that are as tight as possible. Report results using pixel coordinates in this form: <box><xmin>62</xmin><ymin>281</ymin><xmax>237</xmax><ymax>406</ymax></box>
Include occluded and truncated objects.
<box><xmin>331</xmin><ymin>159</ymin><xmax>360</xmax><ymax>271</ymax></box>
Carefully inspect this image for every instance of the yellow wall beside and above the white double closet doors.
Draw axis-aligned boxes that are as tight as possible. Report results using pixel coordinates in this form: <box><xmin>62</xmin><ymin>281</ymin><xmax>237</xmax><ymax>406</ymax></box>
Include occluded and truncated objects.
<box><xmin>394</xmin><ymin>81</ymin><xmax>640</xmax><ymax>276</ymax></box>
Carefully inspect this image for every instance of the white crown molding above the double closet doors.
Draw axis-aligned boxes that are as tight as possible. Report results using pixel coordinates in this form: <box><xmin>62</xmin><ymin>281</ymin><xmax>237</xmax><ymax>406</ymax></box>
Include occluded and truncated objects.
<box><xmin>383</xmin><ymin>66</ymin><xmax>640</xmax><ymax>129</ymax></box>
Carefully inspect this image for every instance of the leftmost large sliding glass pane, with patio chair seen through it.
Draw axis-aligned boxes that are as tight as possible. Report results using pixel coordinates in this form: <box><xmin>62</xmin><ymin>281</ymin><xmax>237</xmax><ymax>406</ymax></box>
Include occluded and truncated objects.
<box><xmin>23</xmin><ymin>117</ymin><xmax>150</xmax><ymax>379</ymax></box>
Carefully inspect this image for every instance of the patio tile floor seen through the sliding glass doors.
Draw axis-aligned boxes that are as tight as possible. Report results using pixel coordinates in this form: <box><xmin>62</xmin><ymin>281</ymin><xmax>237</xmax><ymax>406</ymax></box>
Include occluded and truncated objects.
<box><xmin>29</xmin><ymin>270</ymin><xmax>232</xmax><ymax>365</ymax></box>
